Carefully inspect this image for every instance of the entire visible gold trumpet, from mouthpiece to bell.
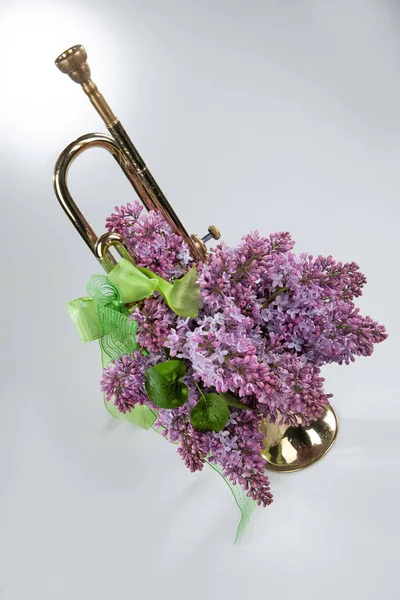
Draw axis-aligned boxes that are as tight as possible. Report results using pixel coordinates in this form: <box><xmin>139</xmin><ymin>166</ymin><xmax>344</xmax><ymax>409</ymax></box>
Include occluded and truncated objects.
<box><xmin>54</xmin><ymin>45</ymin><xmax>338</xmax><ymax>472</ymax></box>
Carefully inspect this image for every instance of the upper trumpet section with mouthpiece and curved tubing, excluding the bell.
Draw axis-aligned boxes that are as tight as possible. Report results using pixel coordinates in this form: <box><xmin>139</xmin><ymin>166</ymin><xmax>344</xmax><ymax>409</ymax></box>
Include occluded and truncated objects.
<box><xmin>54</xmin><ymin>45</ymin><xmax>220</xmax><ymax>270</ymax></box>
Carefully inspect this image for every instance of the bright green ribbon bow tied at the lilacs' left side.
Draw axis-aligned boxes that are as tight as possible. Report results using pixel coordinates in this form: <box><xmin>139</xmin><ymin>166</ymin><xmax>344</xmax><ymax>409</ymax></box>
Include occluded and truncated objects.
<box><xmin>68</xmin><ymin>258</ymin><xmax>200</xmax><ymax>360</ymax></box>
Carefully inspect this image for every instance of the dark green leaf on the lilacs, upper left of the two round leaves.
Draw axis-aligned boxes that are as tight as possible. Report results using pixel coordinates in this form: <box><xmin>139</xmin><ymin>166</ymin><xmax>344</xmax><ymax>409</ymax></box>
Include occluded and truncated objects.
<box><xmin>144</xmin><ymin>360</ymin><xmax>189</xmax><ymax>408</ymax></box>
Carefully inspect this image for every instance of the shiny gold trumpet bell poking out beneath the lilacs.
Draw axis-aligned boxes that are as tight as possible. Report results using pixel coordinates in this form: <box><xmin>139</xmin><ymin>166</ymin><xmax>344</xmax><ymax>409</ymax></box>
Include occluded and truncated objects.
<box><xmin>262</xmin><ymin>405</ymin><xmax>339</xmax><ymax>473</ymax></box>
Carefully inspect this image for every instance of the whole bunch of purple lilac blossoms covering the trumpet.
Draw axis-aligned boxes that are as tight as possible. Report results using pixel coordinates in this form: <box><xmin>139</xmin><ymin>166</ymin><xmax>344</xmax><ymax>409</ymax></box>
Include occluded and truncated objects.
<box><xmin>102</xmin><ymin>203</ymin><xmax>387</xmax><ymax>506</ymax></box>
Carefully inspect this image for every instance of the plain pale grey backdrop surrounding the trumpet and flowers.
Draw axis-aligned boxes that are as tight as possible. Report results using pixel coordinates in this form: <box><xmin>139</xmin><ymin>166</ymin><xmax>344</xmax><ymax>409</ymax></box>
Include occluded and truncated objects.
<box><xmin>0</xmin><ymin>0</ymin><xmax>400</xmax><ymax>600</ymax></box>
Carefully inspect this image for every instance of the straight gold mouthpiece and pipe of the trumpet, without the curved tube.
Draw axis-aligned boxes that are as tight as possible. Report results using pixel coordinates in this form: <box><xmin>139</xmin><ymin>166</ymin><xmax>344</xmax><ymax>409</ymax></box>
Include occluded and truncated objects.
<box><xmin>55</xmin><ymin>45</ymin><xmax>207</xmax><ymax>262</ymax></box>
